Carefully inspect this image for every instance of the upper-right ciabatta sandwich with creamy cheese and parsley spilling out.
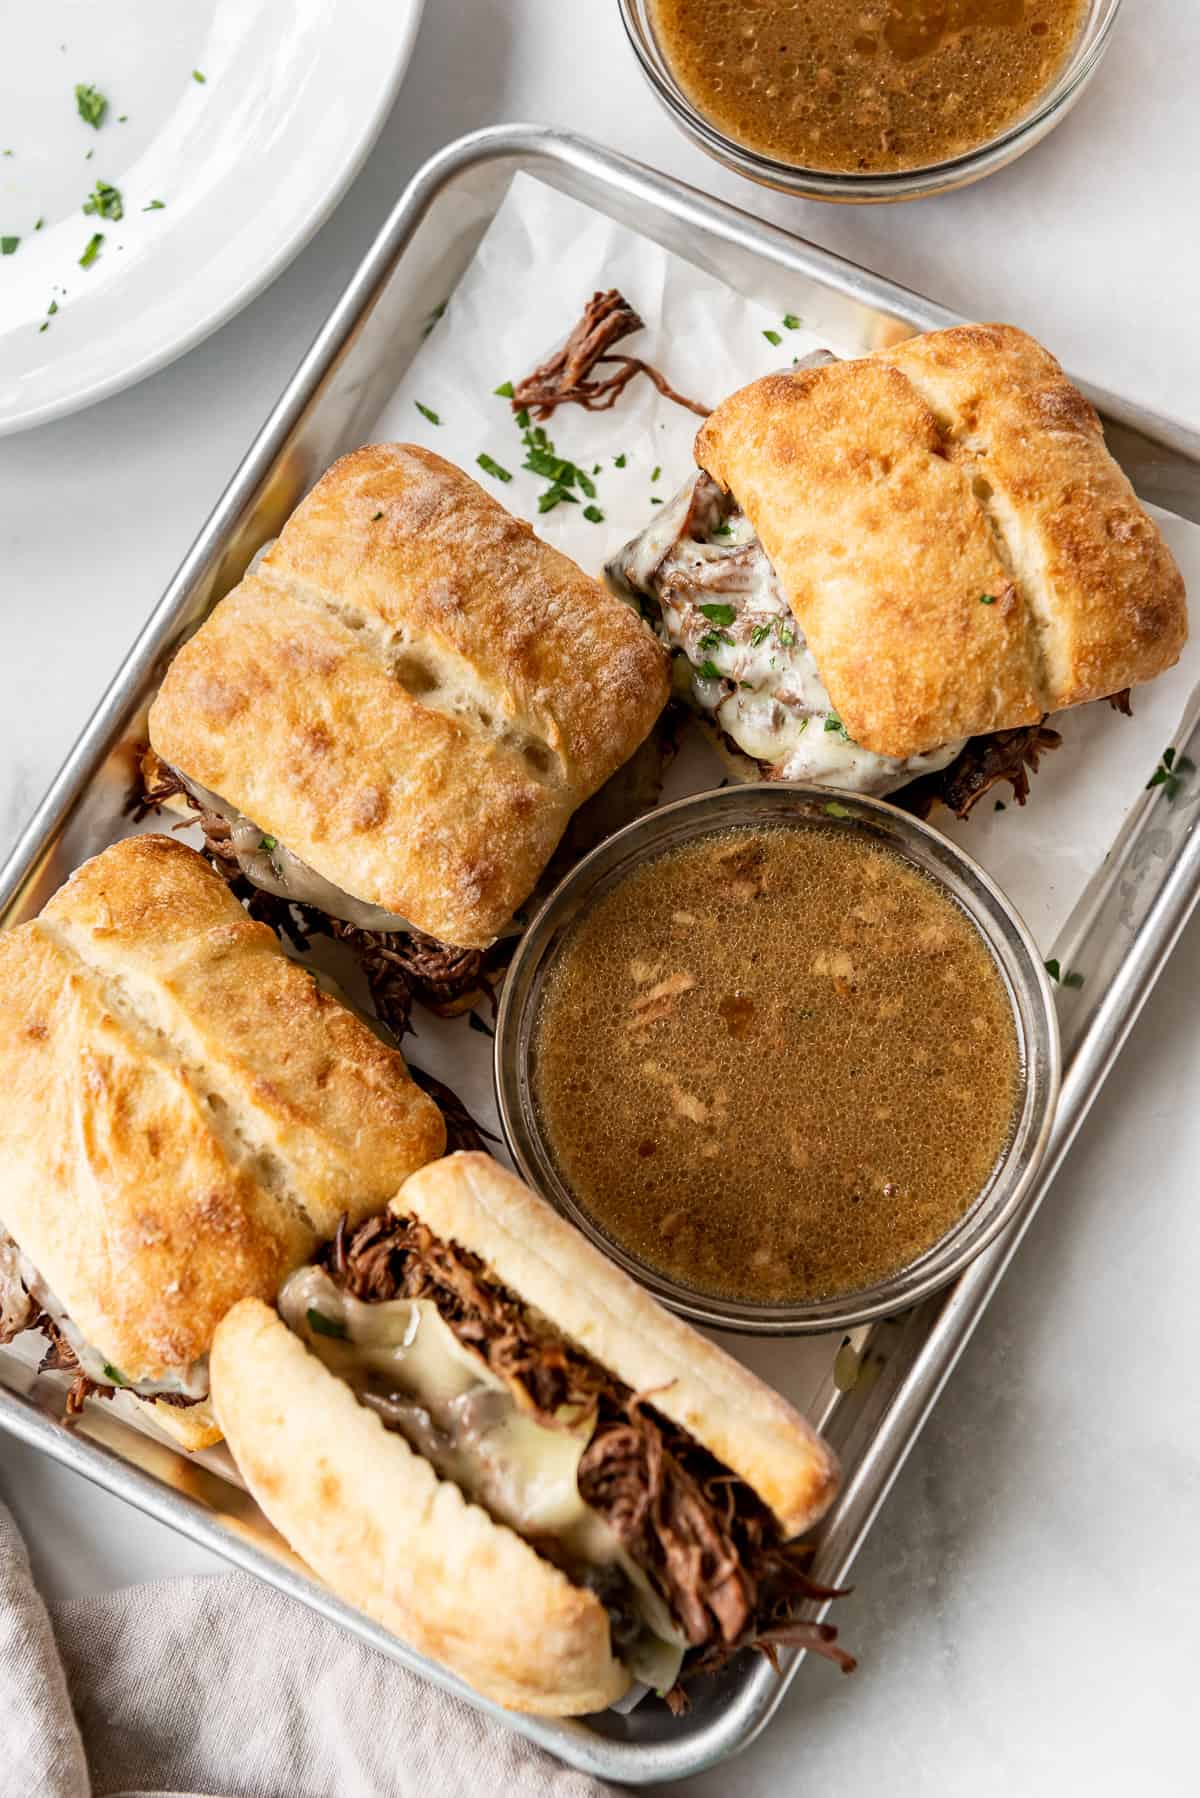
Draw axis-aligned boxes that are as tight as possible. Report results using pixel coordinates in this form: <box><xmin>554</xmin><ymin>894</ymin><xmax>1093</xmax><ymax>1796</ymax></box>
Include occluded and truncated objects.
<box><xmin>610</xmin><ymin>325</ymin><xmax>1187</xmax><ymax>814</ymax></box>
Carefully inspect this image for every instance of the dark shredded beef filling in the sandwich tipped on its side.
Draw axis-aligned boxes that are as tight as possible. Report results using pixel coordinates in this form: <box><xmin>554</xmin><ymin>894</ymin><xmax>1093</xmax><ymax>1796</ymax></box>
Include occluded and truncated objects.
<box><xmin>322</xmin><ymin>1214</ymin><xmax>855</xmax><ymax>1708</ymax></box>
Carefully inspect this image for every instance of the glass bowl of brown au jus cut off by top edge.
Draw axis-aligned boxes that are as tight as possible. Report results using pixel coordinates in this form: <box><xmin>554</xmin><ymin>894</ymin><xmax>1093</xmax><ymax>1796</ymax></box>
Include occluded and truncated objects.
<box><xmin>621</xmin><ymin>0</ymin><xmax>1121</xmax><ymax>201</ymax></box>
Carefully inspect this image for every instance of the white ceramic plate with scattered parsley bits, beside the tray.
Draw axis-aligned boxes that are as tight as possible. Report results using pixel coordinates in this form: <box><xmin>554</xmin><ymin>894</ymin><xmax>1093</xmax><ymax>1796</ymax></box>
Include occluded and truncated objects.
<box><xmin>0</xmin><ymin>0</ymin><xmax>423</xmax><ymax>433</ymax></box>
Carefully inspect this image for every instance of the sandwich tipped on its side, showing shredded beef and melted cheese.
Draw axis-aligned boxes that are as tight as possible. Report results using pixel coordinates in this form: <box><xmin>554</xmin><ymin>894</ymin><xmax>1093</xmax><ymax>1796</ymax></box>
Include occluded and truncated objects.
<box><xmin>212</xmin><ymin>1154</ymin><xmax>849</xmax><ymax>1715</ymax></box>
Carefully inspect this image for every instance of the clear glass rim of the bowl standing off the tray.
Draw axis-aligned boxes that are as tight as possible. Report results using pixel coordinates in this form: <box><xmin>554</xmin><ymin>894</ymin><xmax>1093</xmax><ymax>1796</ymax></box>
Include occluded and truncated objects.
<box><xmin>621</xmin><ymin>0</ymin><xmax>1121</xmax><ymax>203</ymax></box>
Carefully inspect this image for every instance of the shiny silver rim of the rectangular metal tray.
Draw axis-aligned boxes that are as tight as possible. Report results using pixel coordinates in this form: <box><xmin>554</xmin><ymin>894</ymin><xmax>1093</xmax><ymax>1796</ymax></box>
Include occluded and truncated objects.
<box><xmin>0</xmin><ymin>124</ymin><xmax>1200</xmax><ymax>1784</ymax></box>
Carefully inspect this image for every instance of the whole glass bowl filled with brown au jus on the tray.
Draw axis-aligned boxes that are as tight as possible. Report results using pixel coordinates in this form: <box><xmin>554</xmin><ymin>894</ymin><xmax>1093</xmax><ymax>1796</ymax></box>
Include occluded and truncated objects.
<box><xmin>495</xmin><ymin>782</ymin><xmax>1060</xmax><ymax>1334</ymax></box>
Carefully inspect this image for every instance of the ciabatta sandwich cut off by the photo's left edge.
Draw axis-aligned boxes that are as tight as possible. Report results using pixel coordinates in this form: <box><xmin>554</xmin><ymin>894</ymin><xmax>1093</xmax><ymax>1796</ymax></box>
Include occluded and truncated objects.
<box><xmin>0</xmin><ymin>836</ymin><xmax>446</xmax><ymax>1449</ymax></box>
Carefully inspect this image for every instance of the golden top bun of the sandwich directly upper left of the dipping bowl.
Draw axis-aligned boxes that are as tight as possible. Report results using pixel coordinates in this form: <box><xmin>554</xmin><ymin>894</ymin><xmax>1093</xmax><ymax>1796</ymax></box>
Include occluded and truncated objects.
<box><xmin>149</xmin><ymin>444</ymin><xmax>669</xmax><ymax>948</ymax></box>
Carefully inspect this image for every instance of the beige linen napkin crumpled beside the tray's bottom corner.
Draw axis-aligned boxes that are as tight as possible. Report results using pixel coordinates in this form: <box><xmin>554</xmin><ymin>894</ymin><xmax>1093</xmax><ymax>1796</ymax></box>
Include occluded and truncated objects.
<box><xmin>0</xmin><ymin>1505</ymin><xmax>610</xmax><ymax>1798</ymax></box>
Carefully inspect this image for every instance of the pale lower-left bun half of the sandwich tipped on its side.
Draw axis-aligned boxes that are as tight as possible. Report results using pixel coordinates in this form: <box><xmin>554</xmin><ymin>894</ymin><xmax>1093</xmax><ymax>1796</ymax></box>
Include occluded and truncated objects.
<box><xmin>210</xmin><ymin>1298</ymin><xmax>630</xmax><ymax>1717</ymax></box>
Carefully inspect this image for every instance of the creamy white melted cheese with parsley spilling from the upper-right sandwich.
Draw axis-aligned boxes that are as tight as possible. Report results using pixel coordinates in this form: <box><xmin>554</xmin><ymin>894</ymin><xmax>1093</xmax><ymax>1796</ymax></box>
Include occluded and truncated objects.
<box><xmin>608</xmin><ymin>473</ymin><xmax>963</xmax><ymax>795</ymax></box>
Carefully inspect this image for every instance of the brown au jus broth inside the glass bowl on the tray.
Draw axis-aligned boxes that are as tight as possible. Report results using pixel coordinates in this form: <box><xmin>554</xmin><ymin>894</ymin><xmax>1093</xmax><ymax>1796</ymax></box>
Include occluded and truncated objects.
<box><xmin>533</xmin><ymin>825</ymin><xmax>1020</xmax><ymax>1304</ymax></box>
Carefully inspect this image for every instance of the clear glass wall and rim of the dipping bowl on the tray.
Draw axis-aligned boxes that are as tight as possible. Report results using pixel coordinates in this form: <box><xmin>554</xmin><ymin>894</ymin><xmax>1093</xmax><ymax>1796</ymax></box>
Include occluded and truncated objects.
<box><xmin>495</xmin><ymin>782</ymin><xmax>1058</xmax><ymax>1336</ymax></box>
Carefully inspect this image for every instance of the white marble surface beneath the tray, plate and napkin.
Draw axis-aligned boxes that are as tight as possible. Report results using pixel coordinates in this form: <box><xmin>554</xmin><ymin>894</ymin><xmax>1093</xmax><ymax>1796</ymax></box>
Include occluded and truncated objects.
<box><xmin>0</xmin><ymin>0</ymin><xmax>1200</xmax><ymax>1798</ymax></box>
